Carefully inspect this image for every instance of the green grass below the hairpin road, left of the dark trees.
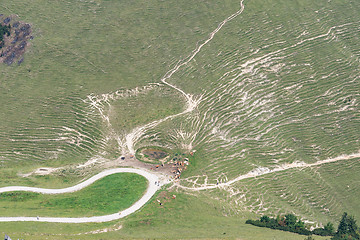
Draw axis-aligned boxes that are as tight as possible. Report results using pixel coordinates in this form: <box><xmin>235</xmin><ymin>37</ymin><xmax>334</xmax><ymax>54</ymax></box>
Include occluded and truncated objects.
<box><xmin>0</xmin><ymin>191</ymin><xmax>326</xmax><ymax>240</ymax></box>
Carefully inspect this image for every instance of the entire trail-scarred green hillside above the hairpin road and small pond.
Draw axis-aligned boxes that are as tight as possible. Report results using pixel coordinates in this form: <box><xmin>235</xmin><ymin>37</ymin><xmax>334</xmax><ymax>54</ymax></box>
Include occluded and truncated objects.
<box><xmin>0</xmin><ymin>0</ymin><xmax>360</xmax><ymax>239</ymax></box>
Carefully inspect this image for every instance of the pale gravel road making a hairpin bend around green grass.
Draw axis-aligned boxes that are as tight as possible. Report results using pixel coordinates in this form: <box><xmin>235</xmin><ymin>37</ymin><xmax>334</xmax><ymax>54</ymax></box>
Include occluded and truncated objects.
<box><xmin>0</xmin><ymin>168</ymin><xmax>168</xmax><ymax>223</ymax></box>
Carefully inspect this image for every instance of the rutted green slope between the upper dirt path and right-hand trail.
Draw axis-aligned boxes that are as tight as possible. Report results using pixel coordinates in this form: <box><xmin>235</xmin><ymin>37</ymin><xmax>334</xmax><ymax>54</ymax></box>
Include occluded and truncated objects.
<box><xmin>154</xmin><ymin>1</ymin><xmax>360</xmax><ymax>178</ymax></box>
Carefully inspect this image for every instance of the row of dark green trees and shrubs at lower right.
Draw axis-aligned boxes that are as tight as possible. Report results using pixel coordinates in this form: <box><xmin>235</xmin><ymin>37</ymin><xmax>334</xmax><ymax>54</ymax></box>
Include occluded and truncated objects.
<box><xmin>246</xmin><ymin>212</ymin><xmax>360</xmax><ymax>240</ymax></box>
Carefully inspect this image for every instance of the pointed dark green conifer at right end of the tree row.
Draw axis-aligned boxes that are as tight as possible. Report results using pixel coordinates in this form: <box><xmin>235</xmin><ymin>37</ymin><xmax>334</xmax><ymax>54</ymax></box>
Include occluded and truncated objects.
<box><xmin>332</xmin><ymin>212</ymin><xmax>360</xmax><ymax>240</ymax></box>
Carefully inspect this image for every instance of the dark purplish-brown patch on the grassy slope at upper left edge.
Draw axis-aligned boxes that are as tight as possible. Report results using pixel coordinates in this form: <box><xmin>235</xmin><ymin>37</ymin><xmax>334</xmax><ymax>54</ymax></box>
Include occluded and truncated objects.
<box><xmin>0</xmin><ymin>14</ymin><xmax>33</xmax><ymax>65</ymax></box>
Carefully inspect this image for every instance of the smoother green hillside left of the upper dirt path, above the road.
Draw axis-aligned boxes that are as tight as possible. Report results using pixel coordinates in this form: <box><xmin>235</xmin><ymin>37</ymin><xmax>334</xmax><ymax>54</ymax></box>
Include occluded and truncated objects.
<box><xmin>0</xmin><ymin>1</ymin><xmax>239</xmax><ymax>167</ymax></box>
